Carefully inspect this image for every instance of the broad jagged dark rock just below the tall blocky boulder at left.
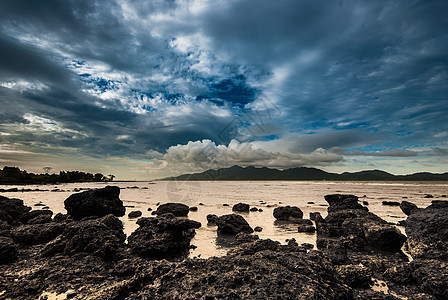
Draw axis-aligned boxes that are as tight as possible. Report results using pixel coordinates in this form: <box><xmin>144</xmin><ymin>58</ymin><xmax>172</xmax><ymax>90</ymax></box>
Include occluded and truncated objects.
<box><xmin>42</xmin><ymin>215</ymin><xmax>126</xmax><ymax>259</ymax></box>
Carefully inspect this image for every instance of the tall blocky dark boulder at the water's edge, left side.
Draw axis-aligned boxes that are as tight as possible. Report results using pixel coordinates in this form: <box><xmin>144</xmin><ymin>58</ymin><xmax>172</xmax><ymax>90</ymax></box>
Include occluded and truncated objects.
<box><xmin>64</xmin><ymin>186</ymin><xmax>126</xmax><ymax>220</ymax></box>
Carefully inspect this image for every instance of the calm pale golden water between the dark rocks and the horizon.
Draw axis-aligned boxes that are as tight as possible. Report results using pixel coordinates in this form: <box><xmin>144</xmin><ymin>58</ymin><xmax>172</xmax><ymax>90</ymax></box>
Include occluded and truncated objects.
<box><xmin>1</xmin><ymin>181</ymin><xmax>448</xmax><ymax>258</ymax></box>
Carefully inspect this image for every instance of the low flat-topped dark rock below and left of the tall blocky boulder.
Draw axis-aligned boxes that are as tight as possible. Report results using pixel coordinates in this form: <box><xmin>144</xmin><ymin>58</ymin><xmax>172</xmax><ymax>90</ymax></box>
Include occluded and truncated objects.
<box><xmin>11</xmin><ymin>223</ymin><xmax>66</xmax><ymax>245</ymax></box>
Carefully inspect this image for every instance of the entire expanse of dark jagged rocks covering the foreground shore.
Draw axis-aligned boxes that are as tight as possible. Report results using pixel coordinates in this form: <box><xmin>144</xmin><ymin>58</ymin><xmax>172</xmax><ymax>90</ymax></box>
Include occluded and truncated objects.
<box><xmin>0</xmin><ymin>187</ymin><xmax>448</xmax><ymax>300</ymax></box>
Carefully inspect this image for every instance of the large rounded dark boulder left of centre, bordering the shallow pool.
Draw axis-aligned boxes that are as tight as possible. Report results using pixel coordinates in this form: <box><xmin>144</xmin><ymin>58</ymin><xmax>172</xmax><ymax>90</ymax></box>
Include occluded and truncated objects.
<box><xmin>128</xmin><ymin>213</ymin><xmax>201</xmax><ymax>259</ymax></box>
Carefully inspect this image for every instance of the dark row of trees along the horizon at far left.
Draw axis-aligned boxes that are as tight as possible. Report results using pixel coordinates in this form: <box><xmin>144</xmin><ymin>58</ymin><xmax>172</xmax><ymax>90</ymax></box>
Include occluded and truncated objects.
<box><xmin>0</xmin><ymin>166</ymin><xmax>115</xmax><ymax>184</ymax></box>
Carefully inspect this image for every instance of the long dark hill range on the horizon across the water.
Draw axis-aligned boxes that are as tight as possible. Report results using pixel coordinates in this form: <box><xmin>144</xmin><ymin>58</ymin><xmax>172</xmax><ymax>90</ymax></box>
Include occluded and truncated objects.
<box><xmin>160</xmin><ymin>166</ymin><xmax>448</xmax><ymax>181</ymax></box>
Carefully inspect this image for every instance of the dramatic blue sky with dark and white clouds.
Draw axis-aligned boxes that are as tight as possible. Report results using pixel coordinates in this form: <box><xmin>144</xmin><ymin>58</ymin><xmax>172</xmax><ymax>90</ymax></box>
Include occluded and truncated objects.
<box><xmin>0</xmin><ymin>0</ymin><xmax>448</xmax><ymax>180</ymax></box>
